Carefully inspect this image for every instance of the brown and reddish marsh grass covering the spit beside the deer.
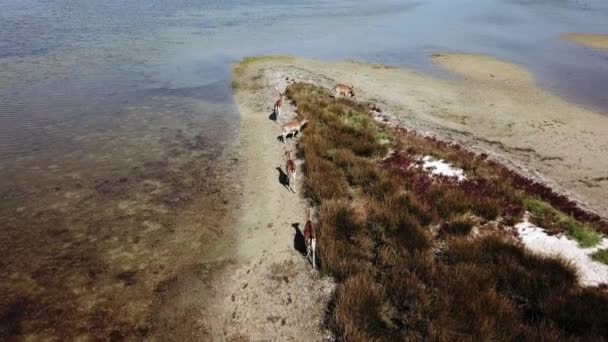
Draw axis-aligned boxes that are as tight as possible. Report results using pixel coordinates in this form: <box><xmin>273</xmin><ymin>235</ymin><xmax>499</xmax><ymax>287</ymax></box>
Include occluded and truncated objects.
<box><xmin>287</xmin><ymin>83</ymin><xmax>608</xmax><ymax>341</ymax></box>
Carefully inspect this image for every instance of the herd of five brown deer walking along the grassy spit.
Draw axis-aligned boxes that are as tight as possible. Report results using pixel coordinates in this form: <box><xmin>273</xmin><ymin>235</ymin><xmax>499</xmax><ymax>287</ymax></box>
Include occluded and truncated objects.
<box><xmin>273</xmin><ymin>84</ymin><xmax>355</xmax><ymax>269</ymax></box>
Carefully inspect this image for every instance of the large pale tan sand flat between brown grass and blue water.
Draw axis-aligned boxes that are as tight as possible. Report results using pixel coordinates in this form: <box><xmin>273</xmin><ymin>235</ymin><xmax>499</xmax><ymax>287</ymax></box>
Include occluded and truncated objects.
<box><xmin>232</xmin><ymin>54</ymin><xmax>608</xmax><ymax>217</ymax></box>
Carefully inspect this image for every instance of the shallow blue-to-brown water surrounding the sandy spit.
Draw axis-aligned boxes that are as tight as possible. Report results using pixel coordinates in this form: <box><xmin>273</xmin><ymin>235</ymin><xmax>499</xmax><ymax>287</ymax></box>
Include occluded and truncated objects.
<box><xmin>0</xmin><ymin>0</ymin><xmax>608</xmax><ymax>339</ymax></box>
